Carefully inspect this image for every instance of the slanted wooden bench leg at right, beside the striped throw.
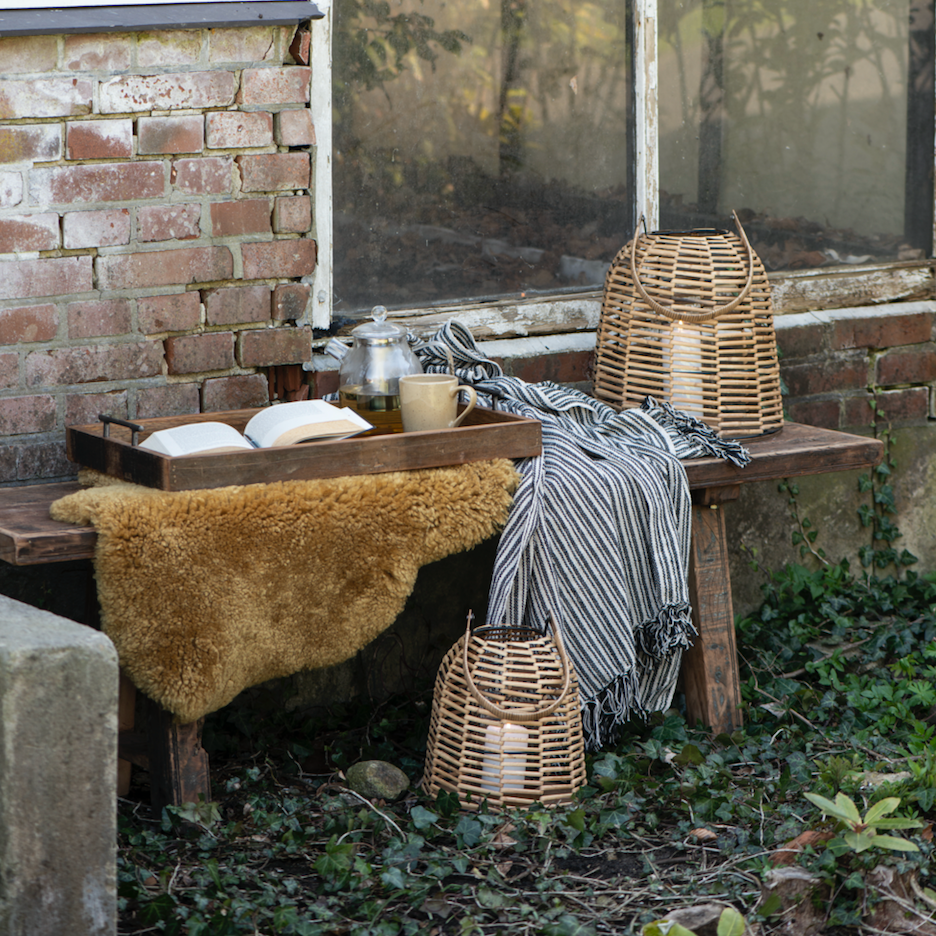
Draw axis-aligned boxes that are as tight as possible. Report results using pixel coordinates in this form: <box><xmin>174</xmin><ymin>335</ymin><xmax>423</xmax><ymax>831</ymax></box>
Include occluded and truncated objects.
<box><xmin>682</xmin><ymin>504</ymin><xmax>742</xmax><ymax>734</ymax></box>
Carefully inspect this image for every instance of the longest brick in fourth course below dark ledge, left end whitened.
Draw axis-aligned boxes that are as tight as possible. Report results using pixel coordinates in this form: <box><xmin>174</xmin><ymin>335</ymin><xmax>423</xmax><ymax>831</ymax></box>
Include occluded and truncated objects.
<box><xmin>29</xmin><ymin>162</ymin><xmax>166</xmax><ymax>205</ymax></box>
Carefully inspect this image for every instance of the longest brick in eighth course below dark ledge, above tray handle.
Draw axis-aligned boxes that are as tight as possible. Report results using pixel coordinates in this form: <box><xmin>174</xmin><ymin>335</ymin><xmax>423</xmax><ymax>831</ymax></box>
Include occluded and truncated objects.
<box><xmin>26</xmin><ymin>341</ymin><xmax>163</xmax><ymax>387</ymax></box>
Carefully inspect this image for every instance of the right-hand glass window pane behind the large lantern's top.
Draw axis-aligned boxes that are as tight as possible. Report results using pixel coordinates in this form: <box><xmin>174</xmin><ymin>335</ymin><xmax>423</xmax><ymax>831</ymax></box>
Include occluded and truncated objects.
<box><xmin>659</xmin><ymin>0</ymin><xmax>933</xmax><ymax>270</ymax></box>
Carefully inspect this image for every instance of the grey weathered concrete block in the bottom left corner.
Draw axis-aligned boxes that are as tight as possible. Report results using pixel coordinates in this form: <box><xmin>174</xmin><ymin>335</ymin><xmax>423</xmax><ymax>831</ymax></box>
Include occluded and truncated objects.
<box><xmin>0</xmin><ymin>595</ymin><xmax>119</xmax><ymax>936</ymax></box>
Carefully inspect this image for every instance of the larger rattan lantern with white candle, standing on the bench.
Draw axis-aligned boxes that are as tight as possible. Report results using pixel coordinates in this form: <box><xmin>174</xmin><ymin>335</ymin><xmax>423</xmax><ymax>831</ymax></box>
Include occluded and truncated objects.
<box><xmin>594</xmin><ymin>215</ymin><xmax>783</xmax><ymax>439</ymax></box>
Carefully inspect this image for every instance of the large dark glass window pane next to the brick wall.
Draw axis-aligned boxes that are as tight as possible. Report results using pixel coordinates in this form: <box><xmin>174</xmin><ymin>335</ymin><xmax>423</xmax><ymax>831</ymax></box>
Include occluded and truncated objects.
<box><xmin>333</xmin><ymin>0</ymin><xmax>633</xmax><ymax>314</ymax></box>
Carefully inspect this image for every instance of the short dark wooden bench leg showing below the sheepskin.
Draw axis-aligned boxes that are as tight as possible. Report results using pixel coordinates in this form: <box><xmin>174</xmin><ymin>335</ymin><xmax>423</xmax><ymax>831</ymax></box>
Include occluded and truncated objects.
<box><xmin>146</xmin><ymin>699</ymin><xmax>211</xmax><ymax>816</ymax></box>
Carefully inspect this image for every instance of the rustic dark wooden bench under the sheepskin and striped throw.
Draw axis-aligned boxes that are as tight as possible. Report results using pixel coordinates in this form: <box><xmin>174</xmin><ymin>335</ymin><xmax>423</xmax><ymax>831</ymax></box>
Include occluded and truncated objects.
<box><xmin>0</xmin><ymin>423</ymin><xmax>883</xmax><ymax>813</ymax></box>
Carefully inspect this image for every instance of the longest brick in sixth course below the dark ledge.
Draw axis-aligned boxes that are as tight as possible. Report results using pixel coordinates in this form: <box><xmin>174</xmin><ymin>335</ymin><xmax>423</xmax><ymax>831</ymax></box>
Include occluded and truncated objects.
<box><xmin>95</xmin><ymin>247</ymin><xmax>234</xmax><ymax>289</ymax></box>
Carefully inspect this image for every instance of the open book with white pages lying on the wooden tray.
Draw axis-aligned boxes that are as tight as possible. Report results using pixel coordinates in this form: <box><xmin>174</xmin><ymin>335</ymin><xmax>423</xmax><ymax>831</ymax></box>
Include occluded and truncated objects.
<box><xmin>140</xmin><ymin>400</ymin><xmax>374</xmax><ymax>455</ymax></box>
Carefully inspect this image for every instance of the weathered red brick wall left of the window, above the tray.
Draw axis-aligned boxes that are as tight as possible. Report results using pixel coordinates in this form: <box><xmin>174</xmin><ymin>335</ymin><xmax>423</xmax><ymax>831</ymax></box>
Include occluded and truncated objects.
<box><xmin>0</xmin><ymin>26</ymin><xmax>316</xmax><ymax>484</ymax></box>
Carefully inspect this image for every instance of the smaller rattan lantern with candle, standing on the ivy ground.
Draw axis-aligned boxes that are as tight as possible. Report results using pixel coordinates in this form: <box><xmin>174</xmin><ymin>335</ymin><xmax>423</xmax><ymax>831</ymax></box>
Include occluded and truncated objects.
<box><xmin>423</xmin><ymin>615</ymin><xmax>585</xmax><ymax>809</ymax></box>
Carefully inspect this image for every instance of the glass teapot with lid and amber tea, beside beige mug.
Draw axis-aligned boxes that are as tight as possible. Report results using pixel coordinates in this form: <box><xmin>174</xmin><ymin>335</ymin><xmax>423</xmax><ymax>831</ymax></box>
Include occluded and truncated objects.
<box><xmin>325</xmin><ymin>306</ymin><xmax>423</xmax><ymax>434</ymax></box>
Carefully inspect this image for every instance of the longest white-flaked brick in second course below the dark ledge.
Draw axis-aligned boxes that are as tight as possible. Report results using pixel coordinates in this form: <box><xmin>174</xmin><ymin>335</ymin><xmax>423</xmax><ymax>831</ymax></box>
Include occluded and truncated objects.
<box><xmin>98</xmin><ymin>71</ymin><xmax>237</xmax><ymax>116</ymax></box>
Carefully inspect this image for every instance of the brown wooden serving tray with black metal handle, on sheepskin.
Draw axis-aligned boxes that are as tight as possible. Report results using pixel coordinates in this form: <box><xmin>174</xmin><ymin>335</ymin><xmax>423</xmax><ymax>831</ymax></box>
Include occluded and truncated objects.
<box><xmin>65</xmin><ymin>406</ymin><xmax>542</xmax><ymax>491</ymax></box>
